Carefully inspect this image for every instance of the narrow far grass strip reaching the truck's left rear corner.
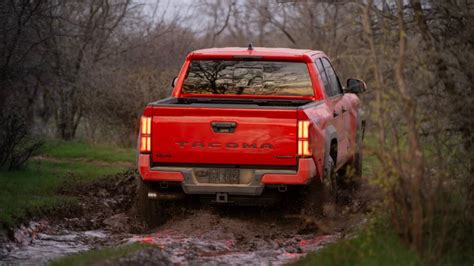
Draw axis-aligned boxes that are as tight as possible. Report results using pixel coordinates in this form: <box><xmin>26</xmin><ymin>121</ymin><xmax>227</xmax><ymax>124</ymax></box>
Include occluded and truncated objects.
<box><xmin>43</xmin><ymin>141</ymin><xmax>135</xmax><ymax>162</ymax></box>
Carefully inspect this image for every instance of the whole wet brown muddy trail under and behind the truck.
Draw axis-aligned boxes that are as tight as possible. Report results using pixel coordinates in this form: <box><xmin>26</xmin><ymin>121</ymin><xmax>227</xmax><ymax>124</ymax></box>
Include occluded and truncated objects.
<box><xmin>0</xmin><ymin>170</ymin><xmax>377</xmax><ymax>265</ymax></box>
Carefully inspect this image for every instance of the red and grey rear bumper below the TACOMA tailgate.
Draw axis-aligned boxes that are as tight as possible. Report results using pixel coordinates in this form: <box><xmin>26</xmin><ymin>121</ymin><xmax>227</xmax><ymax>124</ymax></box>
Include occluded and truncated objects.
<box><xmin>138</xmin><ymin>154</ymin><xmax>316</xmax><ymax>195</ymax></box>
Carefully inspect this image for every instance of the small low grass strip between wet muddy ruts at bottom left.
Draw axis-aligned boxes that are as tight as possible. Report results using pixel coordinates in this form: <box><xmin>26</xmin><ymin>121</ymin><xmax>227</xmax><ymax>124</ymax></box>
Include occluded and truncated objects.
<box><xmin>49</xmin><ymin>243</ymin><xmax>150</xmax><ymax>266</ymax></box>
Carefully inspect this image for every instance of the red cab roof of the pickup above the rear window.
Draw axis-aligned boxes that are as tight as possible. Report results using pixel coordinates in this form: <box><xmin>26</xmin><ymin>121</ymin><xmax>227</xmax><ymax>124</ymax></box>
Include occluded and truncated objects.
<box><xmin>188</xmin><ymin>47</ymin><xmax>324</xmax><ymax>61</ymax></box>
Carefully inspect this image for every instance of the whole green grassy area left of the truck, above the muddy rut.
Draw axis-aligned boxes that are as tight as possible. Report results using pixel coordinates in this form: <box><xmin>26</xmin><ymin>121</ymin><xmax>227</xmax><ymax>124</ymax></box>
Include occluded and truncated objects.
<box><xmin>0</xmin><ymin>142</ymin><xmax>135</xmax><ymax>227</ymax></box>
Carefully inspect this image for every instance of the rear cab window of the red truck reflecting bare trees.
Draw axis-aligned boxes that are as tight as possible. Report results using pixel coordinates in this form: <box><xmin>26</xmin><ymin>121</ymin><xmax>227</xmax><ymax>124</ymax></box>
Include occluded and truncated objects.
<box><xmin>182</xmin><ymin>60</ymin><xmax>313</xmax><ymax>96</ymax></box>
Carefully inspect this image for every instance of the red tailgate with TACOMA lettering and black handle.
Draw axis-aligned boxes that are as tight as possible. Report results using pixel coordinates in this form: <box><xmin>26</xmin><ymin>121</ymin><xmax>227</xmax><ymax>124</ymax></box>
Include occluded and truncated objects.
<box><xmin>151</xmin><ymin>106</ymin><xmax>297</xmax><ymax>166</ymax></box>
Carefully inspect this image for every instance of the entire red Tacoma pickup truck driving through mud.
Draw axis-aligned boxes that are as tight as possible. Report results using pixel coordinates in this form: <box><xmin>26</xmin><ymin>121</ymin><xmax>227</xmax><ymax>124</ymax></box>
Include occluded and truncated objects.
<box><xmin>137</xmin><ymin>45</ymin><xmax>366</xmax><ymax>212</ymax></box>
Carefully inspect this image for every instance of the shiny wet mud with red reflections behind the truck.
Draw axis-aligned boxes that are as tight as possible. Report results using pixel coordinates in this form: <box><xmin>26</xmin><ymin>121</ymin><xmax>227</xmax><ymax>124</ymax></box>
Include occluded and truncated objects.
<box><xmin>123</xmin><ymin>231</ymin><xmax>338</xmax><ymax>265</ymax></box>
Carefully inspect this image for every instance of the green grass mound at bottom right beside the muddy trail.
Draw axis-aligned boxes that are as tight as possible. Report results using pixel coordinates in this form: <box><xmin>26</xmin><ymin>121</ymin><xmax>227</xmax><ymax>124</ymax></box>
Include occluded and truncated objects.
<box><xmin>295</xmin><ymin>224</ymin><xmax>421</xmax><ymax>266</ymax></box>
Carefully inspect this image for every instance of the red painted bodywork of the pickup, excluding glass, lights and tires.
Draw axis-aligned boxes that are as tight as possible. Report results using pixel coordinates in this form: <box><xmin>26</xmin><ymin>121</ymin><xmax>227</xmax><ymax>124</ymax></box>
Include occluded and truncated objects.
<box><xmin>138</xmin><ymin>47</ymin><xmax>360</xmax><ymax>191</ymax></box>
